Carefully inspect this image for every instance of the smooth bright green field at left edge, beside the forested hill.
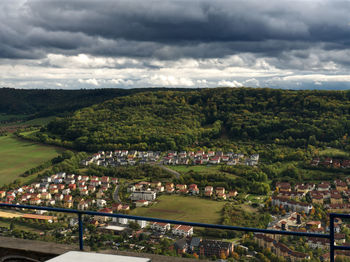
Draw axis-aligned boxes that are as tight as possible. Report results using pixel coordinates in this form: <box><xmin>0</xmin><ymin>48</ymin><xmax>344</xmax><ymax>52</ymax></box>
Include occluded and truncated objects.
<box><xmin>0</xmin><ymin>135</ymin><xmax>63</xmax><ymax>186</ymax></box>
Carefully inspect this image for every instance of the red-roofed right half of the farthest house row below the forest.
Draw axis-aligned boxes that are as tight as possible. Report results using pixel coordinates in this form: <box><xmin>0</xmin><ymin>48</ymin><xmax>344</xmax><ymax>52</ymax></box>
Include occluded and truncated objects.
<box><xmin>162</xmin><ymin>150</ymin><xmax>259</xmax><ymax>166</ymax></box>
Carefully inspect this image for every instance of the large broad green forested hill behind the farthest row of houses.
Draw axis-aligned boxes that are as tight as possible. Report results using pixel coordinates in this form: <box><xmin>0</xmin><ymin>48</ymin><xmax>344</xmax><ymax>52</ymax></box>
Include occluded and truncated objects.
<box><xmin>38</xmin><ymin>88</ymin><xmax>350</xmax><ymax>151</ymax></box>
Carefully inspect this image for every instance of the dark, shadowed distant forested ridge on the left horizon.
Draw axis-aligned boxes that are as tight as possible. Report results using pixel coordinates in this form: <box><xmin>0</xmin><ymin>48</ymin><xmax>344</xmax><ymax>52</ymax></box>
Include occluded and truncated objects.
<box><xmin>0</xmin><ymin>88</ymin><xmax>191</xmax><ymax>118</ymax></box>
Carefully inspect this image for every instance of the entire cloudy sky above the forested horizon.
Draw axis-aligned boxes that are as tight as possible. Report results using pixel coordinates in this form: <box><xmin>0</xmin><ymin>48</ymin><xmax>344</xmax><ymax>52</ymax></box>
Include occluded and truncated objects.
<box><xmin>0</xmin><ymin>0</ymin><xmax>350</xmax><ymax>90</ymax></box>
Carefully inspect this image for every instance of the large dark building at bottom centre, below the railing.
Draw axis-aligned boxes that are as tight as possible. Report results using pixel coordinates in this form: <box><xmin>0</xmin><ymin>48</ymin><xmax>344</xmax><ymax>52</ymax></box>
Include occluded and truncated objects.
<box><xmin>199</xmin><ymin>240</ymin><xmax>233</xmax><ymax>257</ymax></box>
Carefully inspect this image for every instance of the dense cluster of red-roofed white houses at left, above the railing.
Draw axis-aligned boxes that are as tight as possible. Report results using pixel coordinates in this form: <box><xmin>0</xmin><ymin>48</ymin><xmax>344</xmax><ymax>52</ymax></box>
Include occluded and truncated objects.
<box><xmin>0</xmin><ymin>172</ymin><xmax>121</xmax><ymax>213</ymax></box>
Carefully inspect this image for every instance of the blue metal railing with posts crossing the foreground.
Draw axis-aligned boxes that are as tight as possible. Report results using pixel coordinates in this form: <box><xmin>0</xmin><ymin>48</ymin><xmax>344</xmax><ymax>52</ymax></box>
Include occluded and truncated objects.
<box><xmin>0</xmin><ymin>203</ymin><xmax>350</xmax><ymax>262</ymax></box>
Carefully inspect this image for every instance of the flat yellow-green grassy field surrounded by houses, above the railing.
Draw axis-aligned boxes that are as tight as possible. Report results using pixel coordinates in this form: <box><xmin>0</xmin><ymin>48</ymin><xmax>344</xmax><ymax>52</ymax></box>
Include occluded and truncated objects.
<box><xmin>131</xmin><ymin>195</ymin><xmax>225</xmax><ymax>224</ymax></box>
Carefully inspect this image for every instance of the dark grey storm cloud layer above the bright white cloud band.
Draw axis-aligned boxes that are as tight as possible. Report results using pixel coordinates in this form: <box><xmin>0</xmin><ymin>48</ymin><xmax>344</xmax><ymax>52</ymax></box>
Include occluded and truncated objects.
<box><xmin>0</xmin><ymin>0</ymin><xmax>350</xmax><ymax>64</ymax></box>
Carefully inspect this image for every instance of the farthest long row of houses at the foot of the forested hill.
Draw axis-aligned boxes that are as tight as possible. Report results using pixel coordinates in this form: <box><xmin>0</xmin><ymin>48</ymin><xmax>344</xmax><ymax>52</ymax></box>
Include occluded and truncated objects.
<box><xmin>81</xmin><ymin>150</ymin><xmax>259</xmax><ymax>166</ymax></box>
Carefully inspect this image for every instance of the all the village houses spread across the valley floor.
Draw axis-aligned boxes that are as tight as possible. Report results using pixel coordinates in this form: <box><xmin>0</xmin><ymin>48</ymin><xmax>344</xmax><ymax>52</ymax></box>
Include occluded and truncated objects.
<box><xmin>0</xmin><ymin>151</ymin><xmax>350</xmax><ymax>261</ymax></box>
